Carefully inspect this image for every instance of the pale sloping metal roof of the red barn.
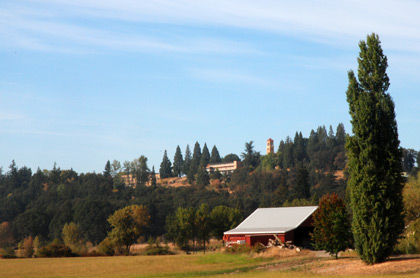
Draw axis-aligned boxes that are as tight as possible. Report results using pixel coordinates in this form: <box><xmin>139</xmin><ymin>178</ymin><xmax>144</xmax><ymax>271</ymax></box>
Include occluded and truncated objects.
<box><xmin>224</xmin><ymin>206</ymin><xmax>318</xmax><ymax>235</ymax></box>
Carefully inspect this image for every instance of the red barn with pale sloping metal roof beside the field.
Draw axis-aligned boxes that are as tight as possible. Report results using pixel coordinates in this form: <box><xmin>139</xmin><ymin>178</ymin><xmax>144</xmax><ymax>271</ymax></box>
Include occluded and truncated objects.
<box><xmin>223</xmin><ymin>206</ymin><xmax>318</xmax><ymax>246</ymax></box>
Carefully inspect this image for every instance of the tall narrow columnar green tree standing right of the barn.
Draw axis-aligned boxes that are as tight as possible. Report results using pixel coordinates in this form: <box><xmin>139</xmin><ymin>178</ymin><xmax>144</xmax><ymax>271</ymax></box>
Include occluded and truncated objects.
<box><xmin>346</xmin><ymin>34</ymin><xmax>404</xmax><ymax>264</ymax></box>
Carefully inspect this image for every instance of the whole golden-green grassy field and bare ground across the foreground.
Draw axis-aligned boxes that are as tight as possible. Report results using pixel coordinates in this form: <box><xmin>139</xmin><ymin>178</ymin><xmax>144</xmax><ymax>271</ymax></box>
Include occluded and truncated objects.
<box><xmin>0</xmin><ymin>250</ymin><xmax>420</xmax><ymax>278</ymax></box>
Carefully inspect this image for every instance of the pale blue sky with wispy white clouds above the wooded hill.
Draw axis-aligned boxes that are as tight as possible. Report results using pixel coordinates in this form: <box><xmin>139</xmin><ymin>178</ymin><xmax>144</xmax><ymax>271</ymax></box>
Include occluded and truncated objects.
<box><xmin>0</xmin><ymin>0</ymin><xmax>420</xmax><ymax>172</ymax></box>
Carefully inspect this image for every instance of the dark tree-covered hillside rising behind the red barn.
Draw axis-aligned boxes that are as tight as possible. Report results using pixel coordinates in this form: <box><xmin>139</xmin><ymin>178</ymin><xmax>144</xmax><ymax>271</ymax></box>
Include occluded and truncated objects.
<box><xmin>0</xmin><ymin>124</ymin><xmax>418</xmax><ymax>244</ymax></box>
